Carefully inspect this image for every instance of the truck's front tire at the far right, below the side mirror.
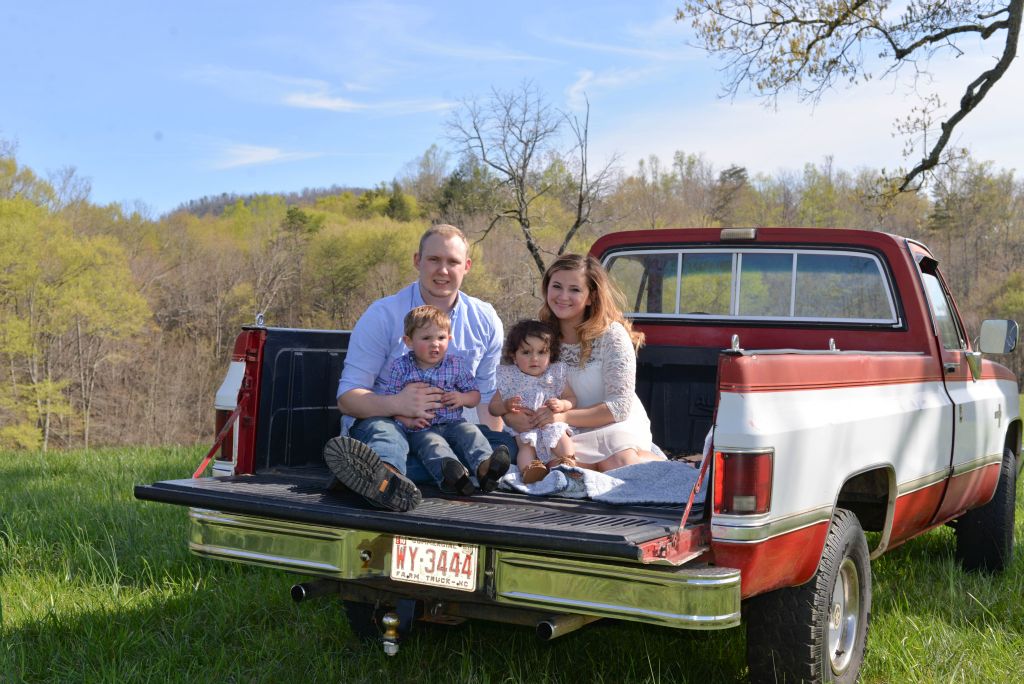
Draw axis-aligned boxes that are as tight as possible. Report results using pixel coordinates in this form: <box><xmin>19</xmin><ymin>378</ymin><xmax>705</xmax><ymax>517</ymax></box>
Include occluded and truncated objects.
<box><xmin>956</xmin><ymin>448</ymin><xmax>1017</xmax><ymax>572</ymax></box>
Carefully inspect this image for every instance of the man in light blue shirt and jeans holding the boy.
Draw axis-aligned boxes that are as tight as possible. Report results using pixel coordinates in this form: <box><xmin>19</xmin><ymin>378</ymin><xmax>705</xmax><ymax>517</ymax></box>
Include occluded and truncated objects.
<box><xmin>324</xmin><ymin>224</ymin><xmax>509</xmax><ymax>511</ymax></box>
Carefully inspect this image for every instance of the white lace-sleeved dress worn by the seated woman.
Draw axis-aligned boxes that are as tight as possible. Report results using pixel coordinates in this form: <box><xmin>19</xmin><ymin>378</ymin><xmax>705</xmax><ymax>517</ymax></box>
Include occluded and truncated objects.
<box><xmin>559</xmin><ymin>323</ymin><xmax>652</xmax><ymax>463</ymax></box>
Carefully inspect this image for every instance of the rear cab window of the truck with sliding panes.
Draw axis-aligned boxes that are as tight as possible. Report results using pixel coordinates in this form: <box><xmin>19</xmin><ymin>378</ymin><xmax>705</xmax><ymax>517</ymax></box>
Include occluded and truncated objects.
<box><xmin>604</xmin><ymin>248</ymin><xmax>899</xmax><ymax>326</ymax></box>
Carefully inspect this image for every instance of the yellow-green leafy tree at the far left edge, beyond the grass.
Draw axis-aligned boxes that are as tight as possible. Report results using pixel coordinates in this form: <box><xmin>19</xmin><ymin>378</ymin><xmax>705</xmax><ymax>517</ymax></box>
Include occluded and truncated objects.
<box><xmin>0</xmin><ymin>197</ymin><xmax>148</xmax><ymax>448</ymax></box>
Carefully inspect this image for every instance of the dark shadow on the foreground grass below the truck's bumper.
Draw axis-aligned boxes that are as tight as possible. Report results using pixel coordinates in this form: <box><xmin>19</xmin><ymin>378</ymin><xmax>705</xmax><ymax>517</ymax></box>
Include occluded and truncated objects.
<box><xmin>4</xmin><ymin>561</ymin><xmax>743</xmax><ymax>683</ymax></box>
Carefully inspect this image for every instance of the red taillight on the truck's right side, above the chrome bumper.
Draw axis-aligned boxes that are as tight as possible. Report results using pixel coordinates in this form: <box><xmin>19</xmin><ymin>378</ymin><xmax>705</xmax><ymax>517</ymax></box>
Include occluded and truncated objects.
<box><xmin>715</xmin><ymin>451</ymin><xmax>774</xmax><ymax>515</ymax></box>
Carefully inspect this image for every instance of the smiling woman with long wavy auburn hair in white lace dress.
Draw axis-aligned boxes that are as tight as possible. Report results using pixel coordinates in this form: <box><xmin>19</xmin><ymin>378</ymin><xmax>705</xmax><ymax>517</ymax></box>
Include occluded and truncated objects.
<box><xmin>513</xmin><ymin>254</ymin><xmax>664</xmax><ymax>472</ymax></box>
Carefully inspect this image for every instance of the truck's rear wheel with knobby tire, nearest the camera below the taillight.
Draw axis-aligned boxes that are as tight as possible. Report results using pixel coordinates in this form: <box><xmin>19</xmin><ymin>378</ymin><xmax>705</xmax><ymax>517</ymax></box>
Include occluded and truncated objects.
<box><xmin>743</xmin><ymin>509</ymin><xmax>871</xmax><ymax>682</ymax></box>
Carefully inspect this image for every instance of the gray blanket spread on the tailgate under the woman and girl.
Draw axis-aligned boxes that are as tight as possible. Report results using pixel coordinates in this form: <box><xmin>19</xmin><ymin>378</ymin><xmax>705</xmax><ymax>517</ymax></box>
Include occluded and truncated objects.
<box><xmin>501</xmin><ymin>461</ymin><xmax>708</xmax><ymax>505</ymax></box>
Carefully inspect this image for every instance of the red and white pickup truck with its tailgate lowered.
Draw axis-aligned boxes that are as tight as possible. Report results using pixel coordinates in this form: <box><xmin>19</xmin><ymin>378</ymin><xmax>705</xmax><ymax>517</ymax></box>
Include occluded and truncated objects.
<box><xmin>135</xmin><ymin>228</ymin><xmax>1022</xmax><ymax>681</ymax></box>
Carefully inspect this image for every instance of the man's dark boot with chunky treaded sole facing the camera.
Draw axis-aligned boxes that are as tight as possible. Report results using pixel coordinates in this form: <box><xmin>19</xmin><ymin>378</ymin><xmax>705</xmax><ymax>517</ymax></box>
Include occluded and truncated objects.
<box><xmin>324</xmin><ymin>437</ymin><xmax>422</xmax><ymax>511</ymax></box>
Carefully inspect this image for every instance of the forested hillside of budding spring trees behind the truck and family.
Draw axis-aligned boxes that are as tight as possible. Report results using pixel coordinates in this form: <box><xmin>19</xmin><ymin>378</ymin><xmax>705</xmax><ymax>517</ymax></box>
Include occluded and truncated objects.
<box><xmin>0</xmin><ymin>144</ymin><xmax>1024</xmax><ymax>448</ymax></box>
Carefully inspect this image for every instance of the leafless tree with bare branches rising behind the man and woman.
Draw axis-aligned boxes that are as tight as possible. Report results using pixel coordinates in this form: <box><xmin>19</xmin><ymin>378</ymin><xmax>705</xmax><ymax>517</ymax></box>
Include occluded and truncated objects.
<box><xmin>447</xmin><ymin>81</ymin><xmax>615</xmax><ymax>273</ymax></box>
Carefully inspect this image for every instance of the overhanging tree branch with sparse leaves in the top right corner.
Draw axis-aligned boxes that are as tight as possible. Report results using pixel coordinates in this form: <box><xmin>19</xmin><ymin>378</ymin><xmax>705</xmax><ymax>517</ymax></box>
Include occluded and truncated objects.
<box><xmin>676</xmin><ymin>0</ymin><xmax>1024</xmax><ymax>191</ymax></box>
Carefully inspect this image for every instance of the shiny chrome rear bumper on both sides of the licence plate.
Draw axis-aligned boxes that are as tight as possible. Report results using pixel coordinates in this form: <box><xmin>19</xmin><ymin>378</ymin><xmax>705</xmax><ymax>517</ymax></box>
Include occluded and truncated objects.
<box><xmin>188</xmin><ymin>509</ymin><xmax>740</xmax><ymax>630</ymax></box>
